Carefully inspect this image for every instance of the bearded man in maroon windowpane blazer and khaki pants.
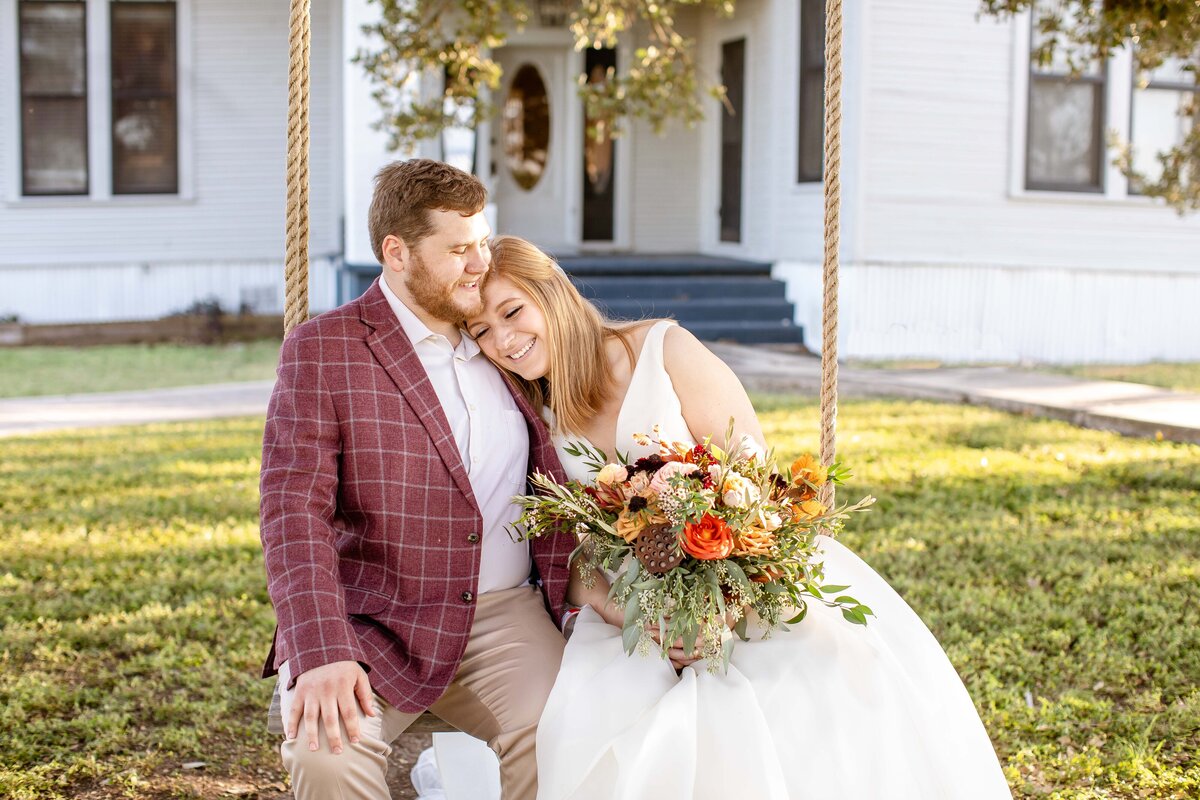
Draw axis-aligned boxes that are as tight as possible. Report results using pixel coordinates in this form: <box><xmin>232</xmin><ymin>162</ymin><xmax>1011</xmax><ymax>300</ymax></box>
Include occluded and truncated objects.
<box><xmin>260</xmin><ymin>160</ymin><xmax>571</xmax><ymax>800</ymax></box>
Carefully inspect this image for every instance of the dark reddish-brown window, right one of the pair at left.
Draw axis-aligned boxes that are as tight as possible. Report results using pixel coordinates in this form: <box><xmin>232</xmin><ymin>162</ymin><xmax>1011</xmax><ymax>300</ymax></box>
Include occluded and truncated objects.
<box><xmin>112</xmin><ymin>2</ymin><xmax>179</xmax><ymax>194</ymax></box>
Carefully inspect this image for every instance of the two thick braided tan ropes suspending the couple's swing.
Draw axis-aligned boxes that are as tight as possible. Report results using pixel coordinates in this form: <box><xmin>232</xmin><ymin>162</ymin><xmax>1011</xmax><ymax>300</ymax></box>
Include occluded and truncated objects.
<box><xmin>283</xmin><ymin>0</ymin><xmax>842</xmax><ymax>507</ymax></box>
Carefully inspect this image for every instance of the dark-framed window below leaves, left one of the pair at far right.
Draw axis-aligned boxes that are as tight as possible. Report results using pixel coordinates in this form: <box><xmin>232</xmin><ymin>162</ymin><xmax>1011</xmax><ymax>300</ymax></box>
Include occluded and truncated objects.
<box><xmin>1025</xmin><ymin>23</ymin><xmax>1106</xmax><ymax>192</ymax></box>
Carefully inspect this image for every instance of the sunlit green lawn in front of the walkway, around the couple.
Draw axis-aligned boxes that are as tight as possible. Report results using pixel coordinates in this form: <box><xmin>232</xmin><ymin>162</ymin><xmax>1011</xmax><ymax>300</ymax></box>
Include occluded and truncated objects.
<box><xmin>0</xmin><ymin>398</ymin><xmax>1200</xmax><ymax>800</ymax></box>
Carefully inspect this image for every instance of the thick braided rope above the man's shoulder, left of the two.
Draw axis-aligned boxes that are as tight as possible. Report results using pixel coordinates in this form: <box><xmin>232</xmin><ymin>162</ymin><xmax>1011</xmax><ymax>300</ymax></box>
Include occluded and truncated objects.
<box><xmin>283</xmin><ymin>0</ymin><xmax>312</xmax><ymax>335</ymax></box>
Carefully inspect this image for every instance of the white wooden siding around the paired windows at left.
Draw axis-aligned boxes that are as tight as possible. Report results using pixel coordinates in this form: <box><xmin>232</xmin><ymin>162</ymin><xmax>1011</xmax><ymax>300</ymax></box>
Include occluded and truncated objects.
<box><xmin>0</xmin><ymin>0</ymin><xmax>342</xmax><ymax>321</ymax></box>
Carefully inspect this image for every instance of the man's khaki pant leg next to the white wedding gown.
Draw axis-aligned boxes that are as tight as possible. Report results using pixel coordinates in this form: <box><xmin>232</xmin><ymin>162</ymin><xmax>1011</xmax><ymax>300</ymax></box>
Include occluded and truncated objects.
<box><xmin>430</xmin><ymin>587</ymin><xmax>564</xmax><ymax>800</ymax></box>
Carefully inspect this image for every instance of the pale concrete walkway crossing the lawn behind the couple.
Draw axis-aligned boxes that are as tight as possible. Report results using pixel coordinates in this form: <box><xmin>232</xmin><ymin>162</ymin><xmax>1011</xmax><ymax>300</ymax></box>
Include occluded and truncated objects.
<box><xmin>0</xmin><ymin>344</ymin><xmax>1200</xmax><ymax>444</ymax></box>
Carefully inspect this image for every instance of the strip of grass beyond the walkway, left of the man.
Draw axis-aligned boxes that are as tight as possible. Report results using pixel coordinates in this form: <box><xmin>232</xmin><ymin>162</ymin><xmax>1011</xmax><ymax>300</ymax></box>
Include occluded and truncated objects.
<box><xmin>0</xmin><ymin>339</ymin><xmax>280</xmax><ymax>397</ymax></box>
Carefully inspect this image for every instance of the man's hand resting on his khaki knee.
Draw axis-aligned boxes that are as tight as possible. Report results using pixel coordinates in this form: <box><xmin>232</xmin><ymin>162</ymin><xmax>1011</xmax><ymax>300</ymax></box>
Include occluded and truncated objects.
<box><xmin>284</xmin><ymin>661</ymin><xmax>376</xmax><ymax>756</ymax></box>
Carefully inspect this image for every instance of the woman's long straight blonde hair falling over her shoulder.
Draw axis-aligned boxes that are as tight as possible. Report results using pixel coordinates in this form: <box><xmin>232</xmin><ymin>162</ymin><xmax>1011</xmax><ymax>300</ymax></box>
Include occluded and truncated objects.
<box><xmin>485</xmin><ymin>236</ymin><xmax>636</xmax><ymax>433</ymax></box>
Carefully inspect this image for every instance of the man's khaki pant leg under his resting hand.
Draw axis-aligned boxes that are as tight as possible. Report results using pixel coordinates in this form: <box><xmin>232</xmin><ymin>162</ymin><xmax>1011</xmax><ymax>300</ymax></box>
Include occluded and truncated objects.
<box><xmin>278</xmin><ymin>663</ymin><xmax>420</xmax><ymax>800</ymax></box>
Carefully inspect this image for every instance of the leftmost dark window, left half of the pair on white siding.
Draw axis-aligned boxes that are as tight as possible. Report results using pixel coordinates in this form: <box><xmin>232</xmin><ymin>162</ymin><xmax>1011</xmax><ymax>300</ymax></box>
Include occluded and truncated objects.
<box><xmin>18</xmin><ymin>0</ymin><xmax>88</xmax><ymax>196</ymax></box>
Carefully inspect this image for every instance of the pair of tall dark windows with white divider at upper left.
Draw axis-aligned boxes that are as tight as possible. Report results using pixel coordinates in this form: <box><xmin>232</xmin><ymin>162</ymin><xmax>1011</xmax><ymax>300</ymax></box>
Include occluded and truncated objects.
<box><xmin>17</xmin><ymin>0</ymin><xmax>180</xmax><ymax>199</ymax></box>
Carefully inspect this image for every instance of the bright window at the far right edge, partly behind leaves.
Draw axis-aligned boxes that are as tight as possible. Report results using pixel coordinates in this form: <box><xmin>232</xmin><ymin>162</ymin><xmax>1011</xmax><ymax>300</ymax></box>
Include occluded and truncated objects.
<box><xmin>1129</xmin><ymin>60</ymin><xmax>1200</xmax><ymax>194</ymax></box>
